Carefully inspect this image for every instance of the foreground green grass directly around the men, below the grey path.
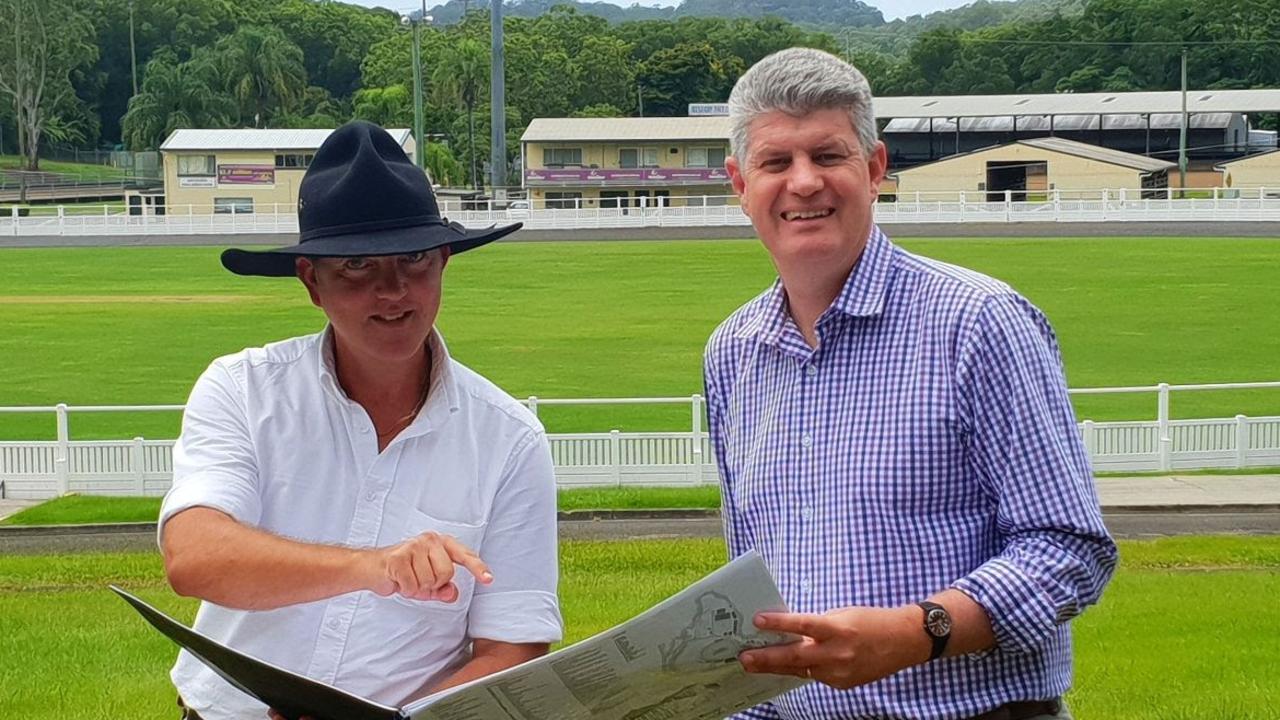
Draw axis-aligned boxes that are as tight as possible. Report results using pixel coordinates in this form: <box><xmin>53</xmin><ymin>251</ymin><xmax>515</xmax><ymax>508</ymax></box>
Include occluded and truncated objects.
<box><xmin>0</xmin><ymin>537</ymin><xmax>1280</xmax><ymax>720</ymax></box>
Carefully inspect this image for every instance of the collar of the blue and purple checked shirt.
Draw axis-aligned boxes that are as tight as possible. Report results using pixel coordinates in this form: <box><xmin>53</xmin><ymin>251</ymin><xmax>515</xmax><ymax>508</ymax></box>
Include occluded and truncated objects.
<box><xmin>737</xmin><ymin>224</ymin><xmax>893</xmax><ymax>345</ymax></box>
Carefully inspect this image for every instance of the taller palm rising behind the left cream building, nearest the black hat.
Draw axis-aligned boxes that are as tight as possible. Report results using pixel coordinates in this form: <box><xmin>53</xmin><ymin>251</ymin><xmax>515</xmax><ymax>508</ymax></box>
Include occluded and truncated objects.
<box><xmin>214</xmin><ymin>26</ymin><xmax>307</xmax><ymax>128</ymax></box>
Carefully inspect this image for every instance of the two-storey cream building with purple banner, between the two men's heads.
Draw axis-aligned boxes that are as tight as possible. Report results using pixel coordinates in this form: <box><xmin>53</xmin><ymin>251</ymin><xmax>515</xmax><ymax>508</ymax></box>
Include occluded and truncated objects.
<box><xmin>520</xmin><ymin>117</ymin><xmax>737</xmax><ymax>209</ymax></box>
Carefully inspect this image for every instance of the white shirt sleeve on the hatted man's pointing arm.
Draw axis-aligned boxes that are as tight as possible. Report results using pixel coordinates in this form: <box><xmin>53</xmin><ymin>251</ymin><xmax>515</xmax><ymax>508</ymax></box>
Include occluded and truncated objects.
<box><xmin>156</xmin><ymin>360</ymin><xmax>262</xmax><ymax>541</ymax></box>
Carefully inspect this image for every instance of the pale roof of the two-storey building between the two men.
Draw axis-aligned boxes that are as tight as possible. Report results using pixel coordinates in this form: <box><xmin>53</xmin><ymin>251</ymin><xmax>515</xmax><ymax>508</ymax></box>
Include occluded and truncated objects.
<box><xmin>520</xmin><ymin>117</ymin><xmax>728</xmax><ymax>142</ymax></box>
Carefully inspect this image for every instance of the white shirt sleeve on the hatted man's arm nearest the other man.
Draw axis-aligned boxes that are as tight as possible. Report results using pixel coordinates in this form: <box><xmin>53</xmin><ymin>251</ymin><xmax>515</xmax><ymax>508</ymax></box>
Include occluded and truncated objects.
<box><xmin>467</xmin><ymin>430</ymin><xmax>563</xmax><ymax>643</ymax></box>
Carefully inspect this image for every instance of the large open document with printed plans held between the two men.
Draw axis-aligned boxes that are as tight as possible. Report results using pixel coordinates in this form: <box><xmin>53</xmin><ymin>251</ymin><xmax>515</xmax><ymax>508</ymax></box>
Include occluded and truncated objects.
<box><xmin>111</xmin><ymin>551</ymin><xmax>806</xmax><ymax>720</ymax></box>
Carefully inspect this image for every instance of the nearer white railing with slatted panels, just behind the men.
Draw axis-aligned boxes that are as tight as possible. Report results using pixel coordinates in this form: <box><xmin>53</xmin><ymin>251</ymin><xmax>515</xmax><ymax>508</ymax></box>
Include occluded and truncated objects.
<box><xmin>0</xmin><ymin>382</ymin><xmax>1280</xmax><ymax>498</ymax></box>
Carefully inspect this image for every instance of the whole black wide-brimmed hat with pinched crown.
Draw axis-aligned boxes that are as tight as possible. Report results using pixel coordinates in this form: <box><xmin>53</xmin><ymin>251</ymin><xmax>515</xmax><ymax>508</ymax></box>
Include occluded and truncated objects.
<box><xmin>221</xmin><ymin>120</ymin><xmax>521</xmax><ymax>277</ymax></box>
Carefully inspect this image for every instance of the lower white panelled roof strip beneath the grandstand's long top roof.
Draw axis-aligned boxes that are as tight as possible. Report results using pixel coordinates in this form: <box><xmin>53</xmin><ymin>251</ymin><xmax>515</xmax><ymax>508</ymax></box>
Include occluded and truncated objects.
<box><xmin>884</xmin><ymin>113</ymin><xmax>1235</xmax><ymax>135</ymax></box>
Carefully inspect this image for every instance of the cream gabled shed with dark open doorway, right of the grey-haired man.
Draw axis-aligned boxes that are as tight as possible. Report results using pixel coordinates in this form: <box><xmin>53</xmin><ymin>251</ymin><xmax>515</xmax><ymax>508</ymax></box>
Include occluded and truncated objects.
<box><xmin>893</xmin><ymin>137</ymin><xmax>1176</xmax><ymax>201</ymax></box>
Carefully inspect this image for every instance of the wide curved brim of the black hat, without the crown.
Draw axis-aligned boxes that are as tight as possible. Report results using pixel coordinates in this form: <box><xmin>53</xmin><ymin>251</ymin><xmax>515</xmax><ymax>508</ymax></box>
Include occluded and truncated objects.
<box><xmin>221</xmin><ymin>217</ymin><xmax>524</xmax><ymax>278</ymax></box>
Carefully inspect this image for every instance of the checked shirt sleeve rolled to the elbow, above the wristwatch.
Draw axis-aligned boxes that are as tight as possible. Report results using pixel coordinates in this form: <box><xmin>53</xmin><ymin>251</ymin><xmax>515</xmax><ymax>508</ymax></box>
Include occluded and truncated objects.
<box><xmin>954</xmin><ymin>293</ymin><xmax>1117</xmax><ymax>652</ymax></box>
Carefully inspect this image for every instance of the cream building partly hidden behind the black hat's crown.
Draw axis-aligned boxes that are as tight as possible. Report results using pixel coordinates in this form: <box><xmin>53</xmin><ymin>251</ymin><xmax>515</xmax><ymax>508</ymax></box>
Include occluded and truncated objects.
<box><xmin>147</xmin><ymin>128</ymin><xmax>415</xmax><ymax>215</ymax></box>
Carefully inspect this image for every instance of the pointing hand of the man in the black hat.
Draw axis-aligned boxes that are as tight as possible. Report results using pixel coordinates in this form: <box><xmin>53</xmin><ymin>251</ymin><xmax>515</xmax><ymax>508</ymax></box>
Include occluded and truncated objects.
<box><xmin>369</xmin><ymin>532</ymin><xmax>493</xmax><ymax>602</ymax></box>
